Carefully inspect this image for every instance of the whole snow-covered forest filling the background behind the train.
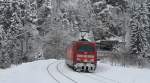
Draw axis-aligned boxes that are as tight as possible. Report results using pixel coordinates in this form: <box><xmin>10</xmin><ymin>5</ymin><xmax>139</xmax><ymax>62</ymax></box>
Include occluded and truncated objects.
<box><xmin>0</xmin><ymin>0</ymin><xmax>150</xmax><ymax>68</ymax></box>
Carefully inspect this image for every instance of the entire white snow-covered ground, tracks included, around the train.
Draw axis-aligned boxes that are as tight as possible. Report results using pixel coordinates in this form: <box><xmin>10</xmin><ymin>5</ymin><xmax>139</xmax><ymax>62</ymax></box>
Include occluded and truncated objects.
<box><xmin>0</xmin><ymin>59</ymin><xmax>150</xmax><ymax>83</ymax></box>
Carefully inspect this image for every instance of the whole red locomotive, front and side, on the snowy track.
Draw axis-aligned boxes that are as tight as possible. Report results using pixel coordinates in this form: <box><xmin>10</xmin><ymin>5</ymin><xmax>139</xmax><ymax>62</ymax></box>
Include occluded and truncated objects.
<box><xmin>66</xmin><ymin>41</ymin><xmax>97</xmax><ymax>72</ymax></box>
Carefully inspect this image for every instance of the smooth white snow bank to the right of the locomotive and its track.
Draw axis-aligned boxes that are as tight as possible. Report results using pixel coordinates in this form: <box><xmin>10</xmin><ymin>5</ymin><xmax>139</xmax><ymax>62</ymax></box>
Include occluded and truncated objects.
<box><xmin>96</xmin><ymin>63</ymin><xmax>150</xmax><ymax>83</ymax></box>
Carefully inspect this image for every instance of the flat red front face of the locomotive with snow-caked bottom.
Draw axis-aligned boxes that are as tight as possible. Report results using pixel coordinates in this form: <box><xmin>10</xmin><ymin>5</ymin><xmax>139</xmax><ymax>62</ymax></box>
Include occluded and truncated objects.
<box><xmin>74</xmin><ymin>41</ymin><xmax>97</xmax><ymax>72</ymax></box>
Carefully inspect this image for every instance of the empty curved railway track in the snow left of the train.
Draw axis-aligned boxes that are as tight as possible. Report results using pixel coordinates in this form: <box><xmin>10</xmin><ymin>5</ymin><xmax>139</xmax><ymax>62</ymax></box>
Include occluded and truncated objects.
<box><xmin>47</xmin><ymin>61</ymin><xmax>77</xmax><ymax>83</ymax></box>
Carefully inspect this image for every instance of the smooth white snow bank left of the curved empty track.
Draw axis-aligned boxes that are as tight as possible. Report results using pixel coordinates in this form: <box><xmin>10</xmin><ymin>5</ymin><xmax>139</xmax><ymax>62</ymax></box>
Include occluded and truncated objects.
<box><xmin>0</xmin><ymin>60</ymin><xmax>55</xmax><ymax>83</ymax></box>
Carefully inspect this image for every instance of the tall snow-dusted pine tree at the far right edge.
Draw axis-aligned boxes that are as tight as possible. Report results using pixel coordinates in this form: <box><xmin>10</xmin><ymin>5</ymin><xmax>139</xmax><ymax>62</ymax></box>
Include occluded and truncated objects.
<box><xmin>130</xmin><ymin>4</ymin><xmax>149</xmax><ymax>59</ymax></box>
